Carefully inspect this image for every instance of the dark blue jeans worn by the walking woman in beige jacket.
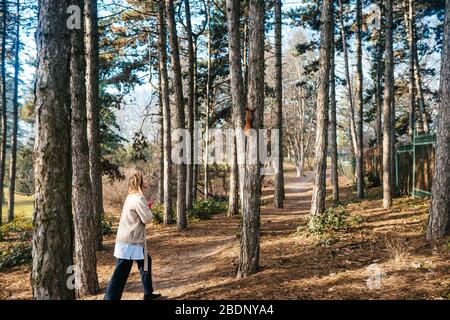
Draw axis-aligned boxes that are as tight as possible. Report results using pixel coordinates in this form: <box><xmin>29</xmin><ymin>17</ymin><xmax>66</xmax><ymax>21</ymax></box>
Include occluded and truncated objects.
<box><xmin>104</xmin><ymin>255</ymin><xmax>153</xmax><ymax>300</ymax></box>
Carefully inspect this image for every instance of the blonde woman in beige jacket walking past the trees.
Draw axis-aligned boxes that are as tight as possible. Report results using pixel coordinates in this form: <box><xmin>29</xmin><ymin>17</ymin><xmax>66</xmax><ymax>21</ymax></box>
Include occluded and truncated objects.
<box><xmin>105</xmin><ymin>172</ymin><xmax>161</xmax><ymax>300</ymax></box>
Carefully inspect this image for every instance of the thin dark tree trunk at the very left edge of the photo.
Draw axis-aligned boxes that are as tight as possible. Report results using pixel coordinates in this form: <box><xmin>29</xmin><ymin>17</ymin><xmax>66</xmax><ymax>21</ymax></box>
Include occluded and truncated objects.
<box><xmin>0</xmin><ymin>0</ymin><xmax>8</xmax><ymax>224</ymax></box>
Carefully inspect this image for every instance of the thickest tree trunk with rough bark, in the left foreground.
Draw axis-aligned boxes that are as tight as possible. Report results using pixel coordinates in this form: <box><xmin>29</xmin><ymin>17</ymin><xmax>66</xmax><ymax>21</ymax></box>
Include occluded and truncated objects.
<box><xmin>31</xmin><ymin>0</ymin><xmax>74</xmax><ymax>300</ymax></box>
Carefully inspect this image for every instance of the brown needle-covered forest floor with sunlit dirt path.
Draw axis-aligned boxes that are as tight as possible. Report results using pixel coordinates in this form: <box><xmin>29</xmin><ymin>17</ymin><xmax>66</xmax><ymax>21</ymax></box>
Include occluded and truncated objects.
<box><xmin>0</xmin><ymin>169</ymin><xmax>450</xmax><ymax>299</ymax></box>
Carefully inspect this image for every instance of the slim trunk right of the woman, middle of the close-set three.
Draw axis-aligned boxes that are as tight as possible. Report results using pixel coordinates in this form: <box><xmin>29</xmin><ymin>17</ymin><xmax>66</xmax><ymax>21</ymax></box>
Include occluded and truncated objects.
<box><xmin>166</xmin><ymin>0</ymin><xmax>187</xmax><ymax>230</ymax></box>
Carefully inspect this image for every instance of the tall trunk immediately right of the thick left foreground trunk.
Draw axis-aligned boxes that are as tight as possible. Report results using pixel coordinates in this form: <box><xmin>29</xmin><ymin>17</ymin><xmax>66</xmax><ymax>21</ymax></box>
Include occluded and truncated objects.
<box><xmin>70</xmin><ymin>0</ymin><xmax>99</xmax><ymax>297</ymax></box>
